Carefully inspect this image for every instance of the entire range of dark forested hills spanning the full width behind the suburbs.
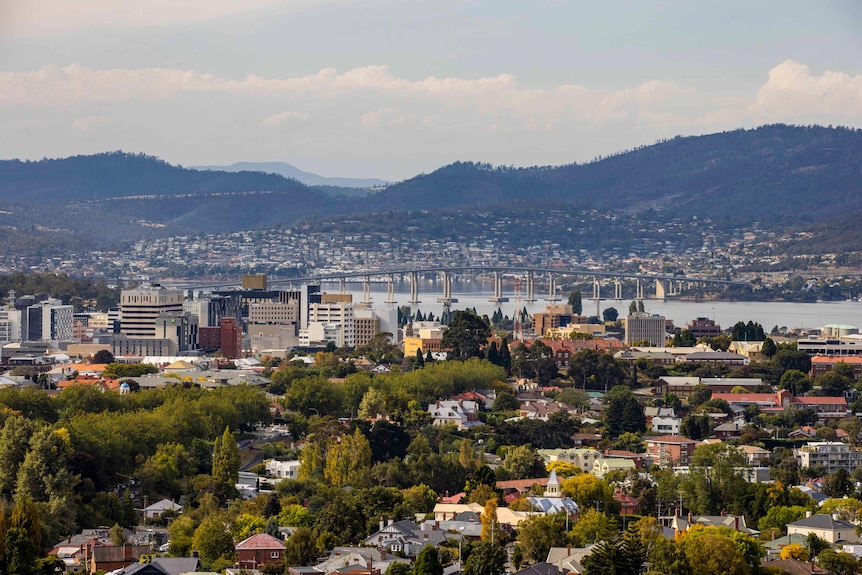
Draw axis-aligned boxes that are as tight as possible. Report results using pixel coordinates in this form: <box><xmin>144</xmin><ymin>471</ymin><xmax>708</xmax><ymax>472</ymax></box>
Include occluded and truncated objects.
<box><xmin>0</xmin><ymin>125</ymin><xmax>862</xmax><ymax>258</ymax></box>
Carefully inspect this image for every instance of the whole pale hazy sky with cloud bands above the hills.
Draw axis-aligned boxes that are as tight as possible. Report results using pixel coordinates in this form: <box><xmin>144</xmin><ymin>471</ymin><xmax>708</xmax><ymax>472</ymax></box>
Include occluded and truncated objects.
<box><xmin>0</xmin><ymin>0</ymin><xmax>862</xmax><ymax>181</ymax></box>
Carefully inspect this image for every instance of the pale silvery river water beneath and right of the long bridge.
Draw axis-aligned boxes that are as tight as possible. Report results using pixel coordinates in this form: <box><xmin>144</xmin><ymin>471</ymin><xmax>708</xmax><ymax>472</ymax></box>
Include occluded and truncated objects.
<box><xmin>322</xmin><ymin>280</ymin><xmax>862</xmax><ymax>332</ymax></box>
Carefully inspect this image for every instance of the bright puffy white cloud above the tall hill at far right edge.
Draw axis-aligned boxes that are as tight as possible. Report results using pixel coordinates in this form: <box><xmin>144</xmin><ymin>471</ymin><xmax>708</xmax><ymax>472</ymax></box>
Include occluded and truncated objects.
<box><xmin>749</xmin><ymin>60</ymin><xmax>862</xmax><ymax>121</ymax></box>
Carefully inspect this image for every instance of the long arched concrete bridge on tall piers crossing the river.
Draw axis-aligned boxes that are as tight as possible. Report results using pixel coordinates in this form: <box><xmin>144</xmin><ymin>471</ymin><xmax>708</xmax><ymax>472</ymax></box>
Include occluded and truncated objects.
<box><xmin>172</xmin><ymin>265</ymin><xmax>748</xmax><ymax>305</ymax></box>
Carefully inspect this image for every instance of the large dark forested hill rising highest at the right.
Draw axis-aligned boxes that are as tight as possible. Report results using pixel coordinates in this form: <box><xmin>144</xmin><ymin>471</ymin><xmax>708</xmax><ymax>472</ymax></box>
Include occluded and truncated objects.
<box><xmin>378</xmin><ymin>125</ymin><xmax>862</xmax><ymax>226</ymax></box>
